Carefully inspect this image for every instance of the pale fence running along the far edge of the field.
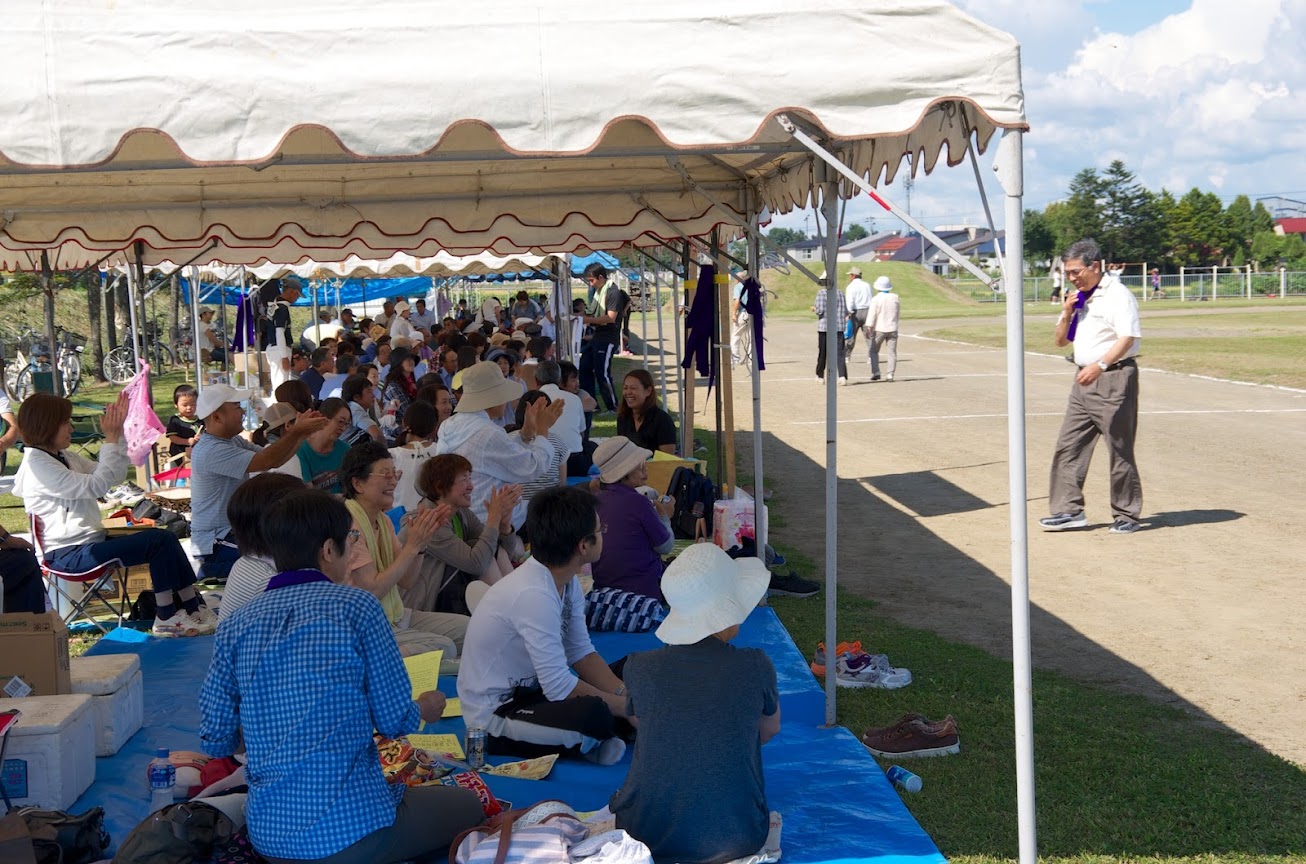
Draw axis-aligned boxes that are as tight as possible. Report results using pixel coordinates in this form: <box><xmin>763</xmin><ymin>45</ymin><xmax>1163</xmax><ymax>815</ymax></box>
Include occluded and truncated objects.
<box><xmin>949</xmin><ymin>268</ymin><xmax>1306</xmax><ymax>303</ymax></box>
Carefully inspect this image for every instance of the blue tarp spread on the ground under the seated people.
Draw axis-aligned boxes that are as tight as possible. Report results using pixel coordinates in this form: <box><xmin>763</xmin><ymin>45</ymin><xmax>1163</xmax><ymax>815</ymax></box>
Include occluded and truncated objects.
<box><xmin>73</xmin><ymin>608</ymin><xmax>944</xmax><ymax>864</ymax></box>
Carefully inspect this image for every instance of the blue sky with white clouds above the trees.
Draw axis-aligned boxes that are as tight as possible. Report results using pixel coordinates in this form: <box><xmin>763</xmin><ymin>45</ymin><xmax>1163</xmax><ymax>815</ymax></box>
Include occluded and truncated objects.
<box><xmin>774</xmin><ymin>0</ymin><xmax>1306</xmax><ymax>230</ymax></box>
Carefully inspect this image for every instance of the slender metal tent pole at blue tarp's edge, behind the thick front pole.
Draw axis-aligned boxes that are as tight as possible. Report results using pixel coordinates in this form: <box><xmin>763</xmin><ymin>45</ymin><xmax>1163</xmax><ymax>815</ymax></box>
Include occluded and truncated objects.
<box><xmin>819</xmin><ymin>166</ymin><xmax>838</xmax><ymax>726</ymax></box>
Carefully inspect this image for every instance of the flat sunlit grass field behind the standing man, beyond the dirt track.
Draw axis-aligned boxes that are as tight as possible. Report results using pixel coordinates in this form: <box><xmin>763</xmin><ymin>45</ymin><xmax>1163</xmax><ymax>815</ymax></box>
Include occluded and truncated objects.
<box><xmin>925</xmin><ymin>307</ymin><xmax>1306</xmax><ymax>388</ymax></box>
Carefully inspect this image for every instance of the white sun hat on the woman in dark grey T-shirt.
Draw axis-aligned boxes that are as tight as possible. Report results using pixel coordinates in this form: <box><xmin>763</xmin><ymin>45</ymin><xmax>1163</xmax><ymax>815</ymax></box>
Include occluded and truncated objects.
<box><xmin>657</xmin><ymin>543</ymin><xmax>771</xmax><ymax>645</ymax></box>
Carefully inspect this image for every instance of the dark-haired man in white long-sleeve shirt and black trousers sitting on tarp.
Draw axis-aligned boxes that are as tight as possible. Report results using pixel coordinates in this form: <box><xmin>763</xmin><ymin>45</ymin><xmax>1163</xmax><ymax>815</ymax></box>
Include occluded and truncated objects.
<box><xmin>458</xmin><ymin>487</ymin><xmax>631</xmax><ymax>765</ymax></box>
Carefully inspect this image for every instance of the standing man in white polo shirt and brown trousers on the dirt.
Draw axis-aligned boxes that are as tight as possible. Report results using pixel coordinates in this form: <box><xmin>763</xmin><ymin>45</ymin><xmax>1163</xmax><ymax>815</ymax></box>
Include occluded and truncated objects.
<box><xmin>1038</xmin><ymin>240</ymin><xmax>1143</xmax><ymax>534</ymax></box>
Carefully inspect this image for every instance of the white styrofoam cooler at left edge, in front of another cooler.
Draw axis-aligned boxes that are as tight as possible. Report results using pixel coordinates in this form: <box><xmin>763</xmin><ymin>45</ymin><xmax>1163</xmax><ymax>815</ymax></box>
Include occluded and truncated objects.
<box><xmin>3</xmin><ymin>693</ymin><xmax>95</xmax><ymax>810</ymax></box>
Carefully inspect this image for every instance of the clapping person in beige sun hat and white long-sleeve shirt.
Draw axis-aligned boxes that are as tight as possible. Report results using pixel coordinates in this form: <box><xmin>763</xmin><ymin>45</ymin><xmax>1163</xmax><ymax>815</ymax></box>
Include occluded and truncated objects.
<box><xmin>435</xmin><ymin>362</ymin><xmax>564</xmax><ymax>529</ymax></box>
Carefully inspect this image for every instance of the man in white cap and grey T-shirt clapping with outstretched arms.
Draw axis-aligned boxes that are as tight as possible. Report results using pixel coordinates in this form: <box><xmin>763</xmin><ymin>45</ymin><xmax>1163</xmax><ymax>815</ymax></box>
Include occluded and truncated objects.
<box><xmin>191</xmin><ymin>384</ymin><xmax>327</xmax><ymax>577</ymax></box>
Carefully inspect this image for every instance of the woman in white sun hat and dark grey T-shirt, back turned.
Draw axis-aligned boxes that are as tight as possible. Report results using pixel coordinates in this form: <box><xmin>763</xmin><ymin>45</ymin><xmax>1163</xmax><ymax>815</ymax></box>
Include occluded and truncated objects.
<box><xmin>610</xmin><ymin>543</ymin><xmax>780</xmax><ymax>864</ymax></box>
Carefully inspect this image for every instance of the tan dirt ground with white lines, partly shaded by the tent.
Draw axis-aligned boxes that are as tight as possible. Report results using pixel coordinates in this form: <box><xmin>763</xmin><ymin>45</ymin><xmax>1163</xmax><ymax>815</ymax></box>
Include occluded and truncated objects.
<box><xmin>645</xmin><ymin>309</ymin><xmax>1306</xmax><ymax>765</ymax></box>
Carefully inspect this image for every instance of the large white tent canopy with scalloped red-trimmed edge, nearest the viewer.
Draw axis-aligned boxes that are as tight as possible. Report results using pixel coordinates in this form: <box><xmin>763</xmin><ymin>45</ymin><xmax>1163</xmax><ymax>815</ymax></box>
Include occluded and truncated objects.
<box><xmin>0</xmin><ymin>0</ymin><xmax>1025</xmax><ymax>266</ymax></box>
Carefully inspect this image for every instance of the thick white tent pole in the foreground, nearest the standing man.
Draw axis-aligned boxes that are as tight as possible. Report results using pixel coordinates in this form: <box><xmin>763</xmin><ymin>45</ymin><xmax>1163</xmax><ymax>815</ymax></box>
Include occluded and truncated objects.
<box><xmin>994</xmin><ymin>131</ymin><xmax>1038</xmax><ymax>864</ymax></box>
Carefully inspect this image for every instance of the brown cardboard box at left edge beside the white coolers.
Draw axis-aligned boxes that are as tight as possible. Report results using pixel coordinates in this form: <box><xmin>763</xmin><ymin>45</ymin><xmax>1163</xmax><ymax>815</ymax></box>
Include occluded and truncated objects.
<box><xmin>0</xmin><ymin>612</ymin><xmax>73</xmax><ymax>698</ymax></box>
